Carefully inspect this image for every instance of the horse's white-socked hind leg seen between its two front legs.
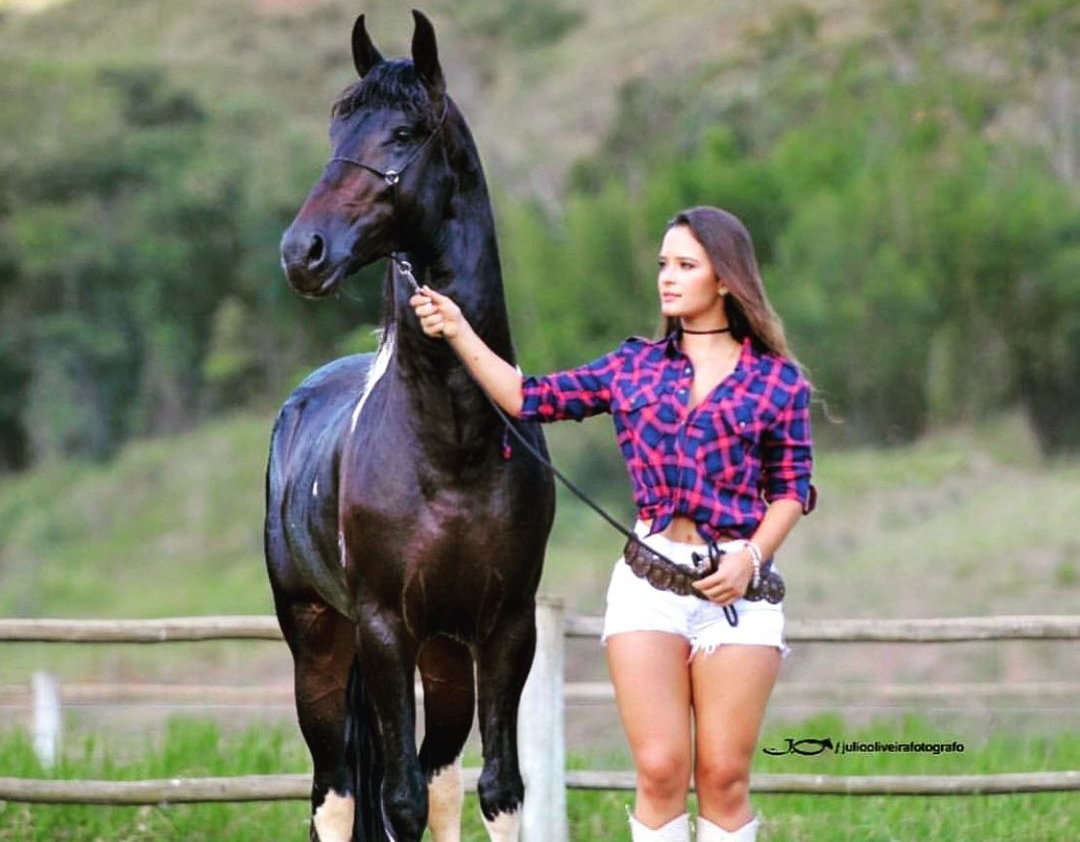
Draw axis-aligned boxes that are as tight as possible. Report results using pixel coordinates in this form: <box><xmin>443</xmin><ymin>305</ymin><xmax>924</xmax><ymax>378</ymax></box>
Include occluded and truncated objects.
<box><xmin>418</xmin><ymin>637</ymin><xmax>476</xmax><ymax>842</ymax></box>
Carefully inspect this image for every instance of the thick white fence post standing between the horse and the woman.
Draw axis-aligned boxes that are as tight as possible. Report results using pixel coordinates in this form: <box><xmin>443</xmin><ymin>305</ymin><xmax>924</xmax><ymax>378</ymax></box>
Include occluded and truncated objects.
<box><xmin>517</xmin><ymin>597</ymin><xmax>569</xmax><ymax>842</ymax></box>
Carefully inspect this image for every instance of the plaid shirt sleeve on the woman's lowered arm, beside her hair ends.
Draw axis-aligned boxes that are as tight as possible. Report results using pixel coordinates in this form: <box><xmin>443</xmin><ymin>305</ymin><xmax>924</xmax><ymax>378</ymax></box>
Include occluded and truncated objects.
<box><xmin>761</xmin><ymin>378</ymin><xmax>818</xmax><ymax>514</ymax></box>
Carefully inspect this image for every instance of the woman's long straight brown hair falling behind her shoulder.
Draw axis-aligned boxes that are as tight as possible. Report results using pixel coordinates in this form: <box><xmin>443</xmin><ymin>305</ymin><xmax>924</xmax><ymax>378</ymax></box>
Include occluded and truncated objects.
<box><xmin>661</xmin><ymin>206</ymin><xmax>795</xmax><ymax>361</ymax></box>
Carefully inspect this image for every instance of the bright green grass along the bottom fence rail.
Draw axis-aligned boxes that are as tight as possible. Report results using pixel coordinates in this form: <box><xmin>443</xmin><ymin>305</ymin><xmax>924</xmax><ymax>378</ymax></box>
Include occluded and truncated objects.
<box><xmin>0</xmin><ymin>714</ymin><xmax>1080</xmax><ymax>842</ymax></box>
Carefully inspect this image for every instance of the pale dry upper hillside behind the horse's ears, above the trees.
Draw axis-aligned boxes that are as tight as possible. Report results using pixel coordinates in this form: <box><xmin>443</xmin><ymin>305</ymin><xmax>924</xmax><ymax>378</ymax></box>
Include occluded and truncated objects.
<box><xmin>0</xmin><ymin>0</ymin><xmax>867</xmax><ymax>194</ymax></box>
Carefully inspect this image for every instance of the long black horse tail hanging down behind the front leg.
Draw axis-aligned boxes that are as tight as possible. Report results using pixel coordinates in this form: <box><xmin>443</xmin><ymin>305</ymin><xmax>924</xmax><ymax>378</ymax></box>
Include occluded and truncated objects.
<box><xmin>345</xmin><ymin>657</ymin><xmax>388</xmax><ymax>842</ymax></box>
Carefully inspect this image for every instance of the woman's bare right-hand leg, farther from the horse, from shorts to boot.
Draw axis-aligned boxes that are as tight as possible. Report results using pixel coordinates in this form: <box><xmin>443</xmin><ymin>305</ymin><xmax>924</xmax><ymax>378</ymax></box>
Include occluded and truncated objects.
<box><xmin>690</xmin><ymin>643</ymin><xmax>781</xmax><ymax>838</ymax></box>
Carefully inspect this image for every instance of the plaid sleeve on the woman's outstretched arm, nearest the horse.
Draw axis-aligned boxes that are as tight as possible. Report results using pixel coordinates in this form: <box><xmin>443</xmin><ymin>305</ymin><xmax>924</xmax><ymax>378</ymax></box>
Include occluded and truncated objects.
<box><xmin>521</xmin><ymin>351</ymin><xmax>622</xmax><ymax>421</ymax></box>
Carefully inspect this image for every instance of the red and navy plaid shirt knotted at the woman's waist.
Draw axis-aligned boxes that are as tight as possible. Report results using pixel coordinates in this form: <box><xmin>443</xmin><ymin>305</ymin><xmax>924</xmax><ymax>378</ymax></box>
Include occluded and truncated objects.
<box><xmin>521</xmin><ymin>334</ymin><xmax>816</xmax><ymax>540</ymax></box>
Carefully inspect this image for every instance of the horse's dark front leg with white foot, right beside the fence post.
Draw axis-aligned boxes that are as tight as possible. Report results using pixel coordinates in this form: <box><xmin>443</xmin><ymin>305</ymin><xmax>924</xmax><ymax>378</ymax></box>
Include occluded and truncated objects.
<box><xmin>476</xmin><ymin>603</ymin><xmax>537</xmax><ymax>842</ymax></box>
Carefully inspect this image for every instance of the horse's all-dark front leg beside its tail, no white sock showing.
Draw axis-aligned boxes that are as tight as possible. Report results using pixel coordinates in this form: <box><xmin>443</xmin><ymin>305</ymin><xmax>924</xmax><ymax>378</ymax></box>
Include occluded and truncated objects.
<box><xmin>354</xmin><ymin>608</ymin><xmax>428</xmax><ymax>842</ymax></box>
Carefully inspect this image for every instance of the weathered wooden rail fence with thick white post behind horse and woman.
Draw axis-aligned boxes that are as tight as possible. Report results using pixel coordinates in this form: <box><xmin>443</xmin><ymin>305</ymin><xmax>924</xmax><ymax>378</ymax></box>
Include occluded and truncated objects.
<box><xmin>0</xmin><ymin>599</ymin><xmax>1080</xmax><ymax>842</ymax></box>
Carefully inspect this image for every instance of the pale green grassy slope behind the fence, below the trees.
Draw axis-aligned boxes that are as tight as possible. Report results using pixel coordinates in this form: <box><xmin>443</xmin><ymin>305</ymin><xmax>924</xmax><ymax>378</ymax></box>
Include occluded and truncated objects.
<box><xmin>0</xmin><ymin>411</ymin><xmax>1080</xmax><ymax>682</ymax></box>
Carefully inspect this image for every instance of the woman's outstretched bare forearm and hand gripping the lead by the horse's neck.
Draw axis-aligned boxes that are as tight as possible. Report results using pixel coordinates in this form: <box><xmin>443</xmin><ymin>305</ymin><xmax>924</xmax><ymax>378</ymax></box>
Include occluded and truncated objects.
<box><xmin>409</xmin><ymin>286</ymin><xmax>523</xmax><ymax>418</ymax></box>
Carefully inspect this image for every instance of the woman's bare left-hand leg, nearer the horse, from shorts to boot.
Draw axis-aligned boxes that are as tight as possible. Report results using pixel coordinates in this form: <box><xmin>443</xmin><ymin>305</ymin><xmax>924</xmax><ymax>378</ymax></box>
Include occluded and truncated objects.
<box><xmin>607</xmin><ymin>632</ymin><xmax>690</xmax><ymax>828</ymax></box>
